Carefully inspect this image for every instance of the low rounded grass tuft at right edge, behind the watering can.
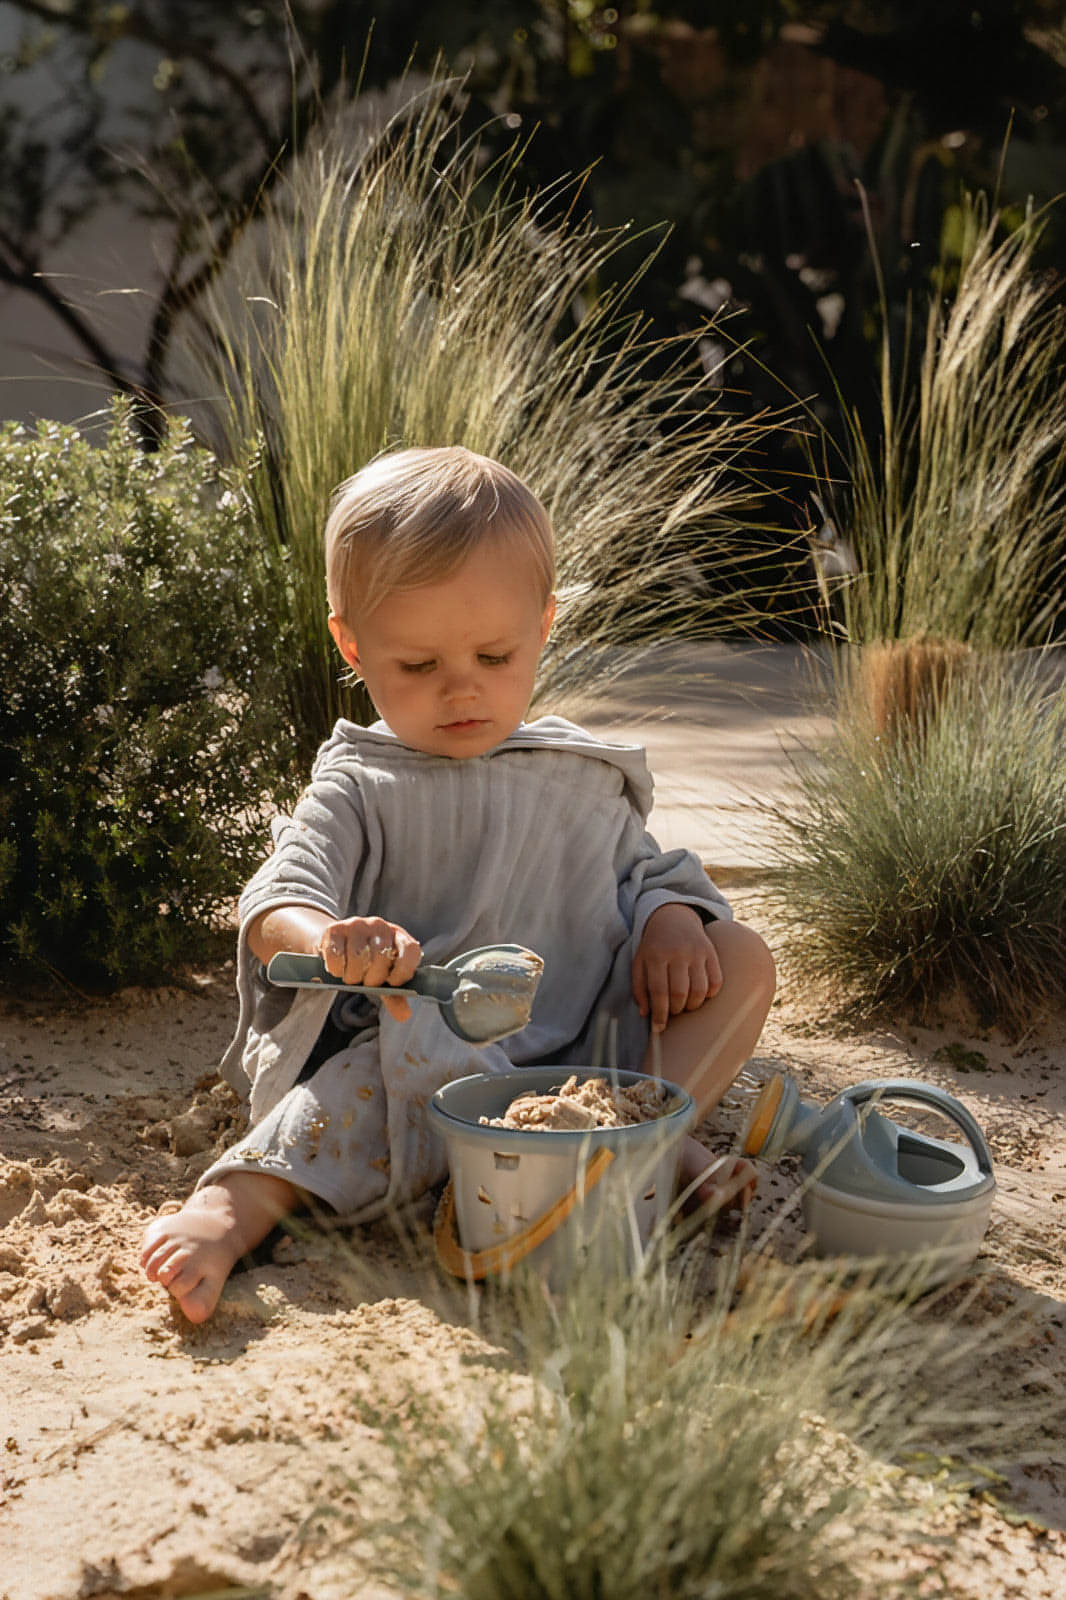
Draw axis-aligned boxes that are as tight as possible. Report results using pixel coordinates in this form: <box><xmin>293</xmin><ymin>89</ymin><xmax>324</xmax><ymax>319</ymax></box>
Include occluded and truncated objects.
<box><xmin>758</xmin><ymin>653</ymin><xmax>1066</xmax><ymax>1030</ymax></box>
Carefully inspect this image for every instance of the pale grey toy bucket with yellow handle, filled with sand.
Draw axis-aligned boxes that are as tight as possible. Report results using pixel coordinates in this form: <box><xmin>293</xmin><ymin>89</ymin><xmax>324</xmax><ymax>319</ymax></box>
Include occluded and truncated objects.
<box><xmin>427</xmin><ymin>1067</ymin><xmax>696</xmax><ymax>1288</ymax></box>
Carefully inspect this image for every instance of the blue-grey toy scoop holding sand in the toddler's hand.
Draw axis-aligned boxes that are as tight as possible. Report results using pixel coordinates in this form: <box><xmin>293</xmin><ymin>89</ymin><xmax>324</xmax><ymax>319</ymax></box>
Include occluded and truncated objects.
<box><xmin>267</xmin><ymin>944</ymin><xmax>544</xmax><ymax>1045</ymax></box>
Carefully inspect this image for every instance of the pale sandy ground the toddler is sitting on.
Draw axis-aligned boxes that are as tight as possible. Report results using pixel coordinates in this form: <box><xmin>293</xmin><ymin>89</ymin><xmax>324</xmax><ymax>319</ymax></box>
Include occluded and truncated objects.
<box><xmin>0</xmin><ymin>652</ymin><xmax>1066</xmax><ymax>1600</ymax></box>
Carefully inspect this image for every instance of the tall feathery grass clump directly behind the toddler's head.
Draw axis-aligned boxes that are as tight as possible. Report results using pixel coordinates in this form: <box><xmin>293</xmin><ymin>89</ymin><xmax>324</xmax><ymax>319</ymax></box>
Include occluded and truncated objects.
<box><xmin>192</xmin><ymin>82</ymin><xmax>797</xmax><ymax>761</ymax></box>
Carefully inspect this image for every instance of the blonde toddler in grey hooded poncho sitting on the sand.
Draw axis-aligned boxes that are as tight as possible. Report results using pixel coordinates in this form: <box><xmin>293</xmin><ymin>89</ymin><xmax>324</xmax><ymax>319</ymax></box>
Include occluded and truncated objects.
<box><xmin>141</xmin><ymin>448</ymin><xmax>775</xmax><ymax>1322</ymax></box>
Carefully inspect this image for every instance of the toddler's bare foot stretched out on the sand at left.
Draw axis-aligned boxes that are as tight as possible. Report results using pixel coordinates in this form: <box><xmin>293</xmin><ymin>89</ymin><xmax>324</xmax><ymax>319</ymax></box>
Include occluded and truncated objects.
<box><xmin>141</xmin><ymin>1173</ymin><xmax>298</xmax><ymax>1322</ymax></box>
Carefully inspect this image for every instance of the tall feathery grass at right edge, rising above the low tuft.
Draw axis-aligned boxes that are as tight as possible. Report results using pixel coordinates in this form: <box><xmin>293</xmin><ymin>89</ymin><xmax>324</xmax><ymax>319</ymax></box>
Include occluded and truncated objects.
<box><xmin>809</xmin><ymin>200</ymin><xmax>1066</xmax><ymax>648</ymax></box>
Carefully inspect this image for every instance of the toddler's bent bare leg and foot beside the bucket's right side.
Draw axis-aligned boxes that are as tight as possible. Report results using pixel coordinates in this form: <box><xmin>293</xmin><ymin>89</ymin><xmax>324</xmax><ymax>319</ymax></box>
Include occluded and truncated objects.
<box><xmin>642</xmin><ymin>922</ymin><xmax>776</xmax><ymax>1203</ymax></box>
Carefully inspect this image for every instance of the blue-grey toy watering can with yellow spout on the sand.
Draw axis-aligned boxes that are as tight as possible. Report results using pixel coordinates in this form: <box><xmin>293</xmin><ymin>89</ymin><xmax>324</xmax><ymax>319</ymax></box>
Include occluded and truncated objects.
<box><xmin>741</xmin><ymin>1074</ymin><xmax>996</xmax><ymax>1283</ymax></box>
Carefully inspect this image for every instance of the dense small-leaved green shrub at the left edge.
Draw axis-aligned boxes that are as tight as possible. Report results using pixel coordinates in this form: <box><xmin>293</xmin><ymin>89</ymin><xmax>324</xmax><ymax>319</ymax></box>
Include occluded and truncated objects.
<box><xmin>0</xmin><ymin>406</ymin><xmax>299</xmax><ymax>984</ymax></box>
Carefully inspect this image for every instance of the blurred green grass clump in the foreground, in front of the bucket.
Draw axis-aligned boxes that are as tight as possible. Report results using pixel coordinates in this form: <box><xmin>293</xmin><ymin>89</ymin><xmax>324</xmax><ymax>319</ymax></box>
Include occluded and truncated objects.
<box><xmin>327</xmin><ymin>1237</ymin><xmax>1048</xmax><ymax>1600</ymax></box>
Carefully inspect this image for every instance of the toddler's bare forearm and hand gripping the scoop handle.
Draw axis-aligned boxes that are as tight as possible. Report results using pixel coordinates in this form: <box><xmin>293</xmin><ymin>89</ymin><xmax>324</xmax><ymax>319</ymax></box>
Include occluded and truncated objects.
<box><xmin>248</xmin><ymin>906</ymin><xmax>423</xmax><ymax>1022</ymax></box>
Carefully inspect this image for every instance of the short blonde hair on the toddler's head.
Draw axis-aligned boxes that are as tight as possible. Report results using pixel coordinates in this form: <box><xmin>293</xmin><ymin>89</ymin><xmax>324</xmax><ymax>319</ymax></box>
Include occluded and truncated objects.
<box><xmin>325</xmin><ymin>445</ymin><xmax>555</xmax><ymax>624</ymax></box>
